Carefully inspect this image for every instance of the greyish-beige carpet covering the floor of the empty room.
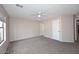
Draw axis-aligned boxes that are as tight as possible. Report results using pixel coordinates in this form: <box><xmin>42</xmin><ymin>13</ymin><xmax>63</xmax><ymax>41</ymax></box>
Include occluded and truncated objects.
<box><xmin>6</xmin><ymin>36</ymin><xmax>79</xmax><ymax>54</ymax></box>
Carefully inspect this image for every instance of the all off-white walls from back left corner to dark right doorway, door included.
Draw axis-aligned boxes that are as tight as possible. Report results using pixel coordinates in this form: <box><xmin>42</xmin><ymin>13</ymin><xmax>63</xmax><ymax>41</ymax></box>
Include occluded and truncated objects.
<box><xmin>9</xmin><ymin>15</ymin><xmax>74</xmax><ymax>42</ymax></box>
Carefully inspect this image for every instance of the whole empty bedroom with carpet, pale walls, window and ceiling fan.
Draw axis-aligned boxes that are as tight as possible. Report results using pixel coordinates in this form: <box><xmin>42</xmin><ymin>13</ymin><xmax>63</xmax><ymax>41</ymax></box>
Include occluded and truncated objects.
<box><xmin>0</xmin><ymin>4</ymin><xmax>79</xmax><ymax>54</ymax></box>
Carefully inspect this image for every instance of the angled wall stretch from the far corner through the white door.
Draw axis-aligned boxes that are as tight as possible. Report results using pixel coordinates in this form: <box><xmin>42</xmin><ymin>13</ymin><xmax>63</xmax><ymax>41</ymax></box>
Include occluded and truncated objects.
<box><xmin>41</xmin><ymin>17</ymin><xmax>62</xmax><ymax>41</ymax></box>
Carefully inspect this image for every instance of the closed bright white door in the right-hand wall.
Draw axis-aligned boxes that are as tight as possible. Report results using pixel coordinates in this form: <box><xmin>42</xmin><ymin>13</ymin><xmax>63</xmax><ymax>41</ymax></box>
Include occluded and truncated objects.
<box><xmin>52</xmin><ymin>19</ymin><xmax>60</xmax><ymax>40</ymax></box>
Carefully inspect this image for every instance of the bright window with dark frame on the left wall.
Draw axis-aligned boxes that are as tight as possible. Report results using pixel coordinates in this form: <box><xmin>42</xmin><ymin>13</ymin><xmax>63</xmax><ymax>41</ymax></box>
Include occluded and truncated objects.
<box><xmin>0</xmin><ymin>20</ymin><xmax>6</xmax><ymax>44</ymax></box>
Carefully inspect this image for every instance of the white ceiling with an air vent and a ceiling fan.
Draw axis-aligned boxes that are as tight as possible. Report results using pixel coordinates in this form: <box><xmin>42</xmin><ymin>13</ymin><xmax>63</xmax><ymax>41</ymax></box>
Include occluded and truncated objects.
<box><xmin>3</xmin><ymin>4</ymin><xmax>79</xmax><ymax>19</ymax></box>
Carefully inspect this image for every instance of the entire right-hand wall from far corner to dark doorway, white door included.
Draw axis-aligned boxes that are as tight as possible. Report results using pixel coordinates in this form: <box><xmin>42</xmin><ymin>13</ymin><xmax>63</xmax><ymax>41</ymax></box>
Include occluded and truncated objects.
<box><xmin>43</xmin><ymin>15</ymin><xmax>74</xmax><ymax>42</ymax></box>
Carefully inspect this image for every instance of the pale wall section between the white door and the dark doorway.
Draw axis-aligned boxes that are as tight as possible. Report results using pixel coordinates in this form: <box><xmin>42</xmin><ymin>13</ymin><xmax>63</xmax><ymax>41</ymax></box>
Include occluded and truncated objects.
<box><xmin>61</xmin><ymin>15</ymin><xmax>74</xmax><ymax>42</ymax></box>
